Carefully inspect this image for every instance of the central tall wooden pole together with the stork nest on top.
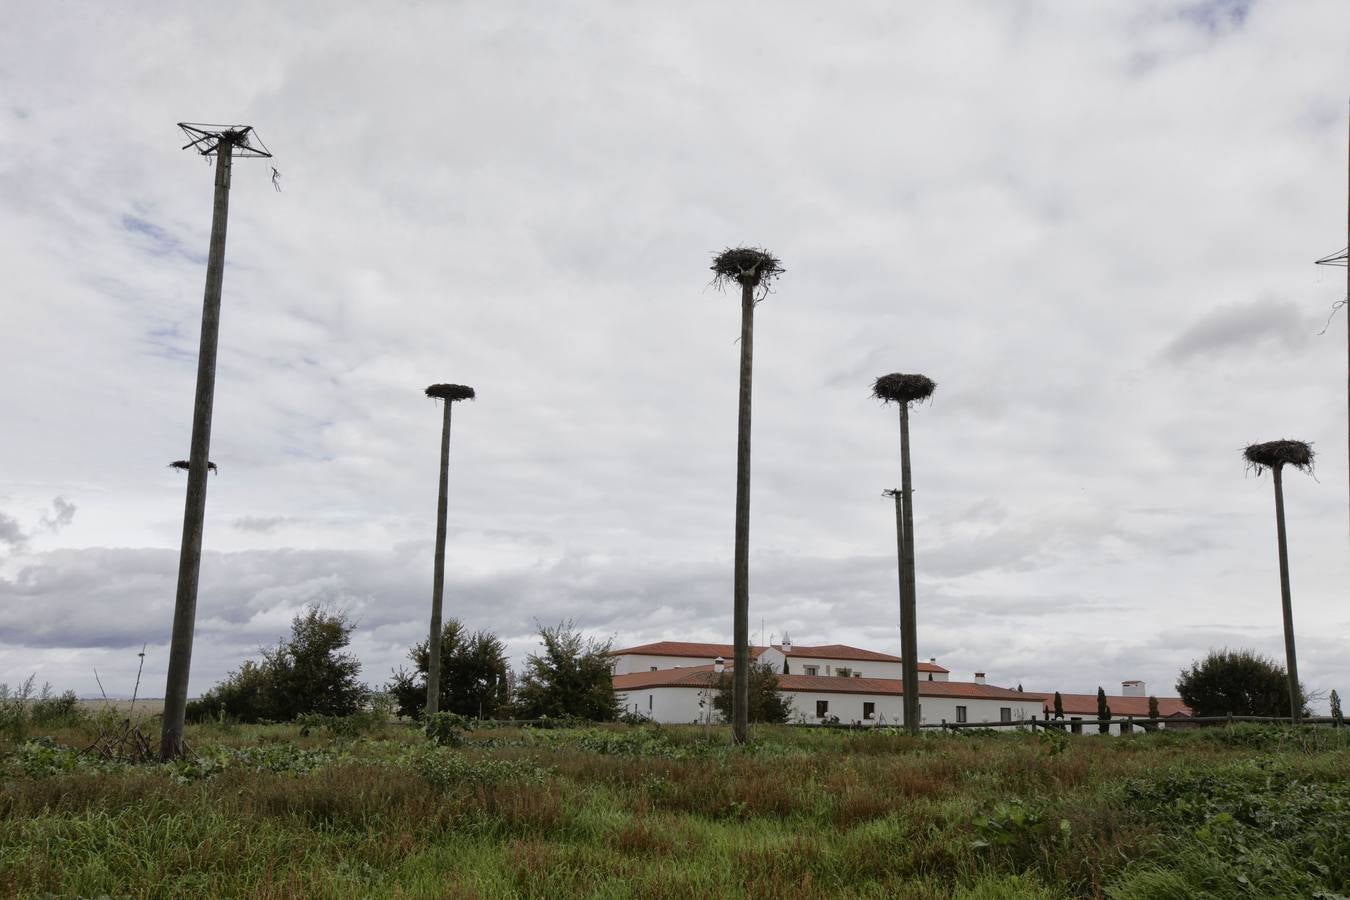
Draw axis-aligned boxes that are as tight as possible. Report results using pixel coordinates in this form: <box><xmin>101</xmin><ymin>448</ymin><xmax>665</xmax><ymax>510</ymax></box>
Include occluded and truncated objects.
<box><xmin>711</xmin><ymin>247</ymin><xmax>783</xmax><ymax>743</ymax></box>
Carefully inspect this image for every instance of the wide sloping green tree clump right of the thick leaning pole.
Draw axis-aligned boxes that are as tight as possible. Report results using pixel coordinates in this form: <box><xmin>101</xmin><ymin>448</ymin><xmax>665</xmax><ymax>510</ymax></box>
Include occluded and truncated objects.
<box><xmin>189</xmin><ymin>606</ymin><xmax>369</xmax><ymax>722</ymax></box>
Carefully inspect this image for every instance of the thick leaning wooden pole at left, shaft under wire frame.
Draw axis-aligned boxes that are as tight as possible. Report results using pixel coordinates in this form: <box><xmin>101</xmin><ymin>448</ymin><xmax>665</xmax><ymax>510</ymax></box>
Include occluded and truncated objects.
<box><xmin>159</xmin><ymin>136</ymin><xmax>234</xmax><ymax>760</ymax></box>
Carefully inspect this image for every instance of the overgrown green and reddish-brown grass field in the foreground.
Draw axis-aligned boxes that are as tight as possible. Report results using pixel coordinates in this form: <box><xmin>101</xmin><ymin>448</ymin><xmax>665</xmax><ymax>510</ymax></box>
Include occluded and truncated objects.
<box><xmin>0</xmin><ymin>722</ymin><xmax>1350</xmax><ymax>900</ymax></box>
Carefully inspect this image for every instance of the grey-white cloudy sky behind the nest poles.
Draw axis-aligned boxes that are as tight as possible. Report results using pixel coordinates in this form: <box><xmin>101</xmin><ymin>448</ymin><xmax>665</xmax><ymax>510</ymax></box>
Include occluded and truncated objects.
<box><xmin>0</xmin><ymin>0</ymin><xmax>1350</xmax><ymax>696</ymax></box>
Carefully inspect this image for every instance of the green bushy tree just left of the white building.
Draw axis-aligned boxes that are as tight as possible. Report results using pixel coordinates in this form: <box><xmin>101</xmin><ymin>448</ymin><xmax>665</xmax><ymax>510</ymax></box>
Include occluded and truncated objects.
<box><xmin>516</xmin><ymin>621</ymin><xmax>620</xmax><ymax>722</ymax></box>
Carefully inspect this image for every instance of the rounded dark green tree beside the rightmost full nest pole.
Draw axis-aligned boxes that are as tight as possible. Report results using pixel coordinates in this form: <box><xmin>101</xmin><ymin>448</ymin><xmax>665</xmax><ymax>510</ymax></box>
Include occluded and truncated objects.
<box><xmin>1177</xmin><ymin>649</ymin><xmax>1304</xmax><ymax>718</ymax></box>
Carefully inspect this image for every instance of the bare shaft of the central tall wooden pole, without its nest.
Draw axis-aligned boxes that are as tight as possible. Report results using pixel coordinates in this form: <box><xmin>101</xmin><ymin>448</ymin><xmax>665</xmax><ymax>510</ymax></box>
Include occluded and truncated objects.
<box><xmin>732</xmin><ymin>282</ymin><xmax>755</xmax><ymax>743</ymax></box>
